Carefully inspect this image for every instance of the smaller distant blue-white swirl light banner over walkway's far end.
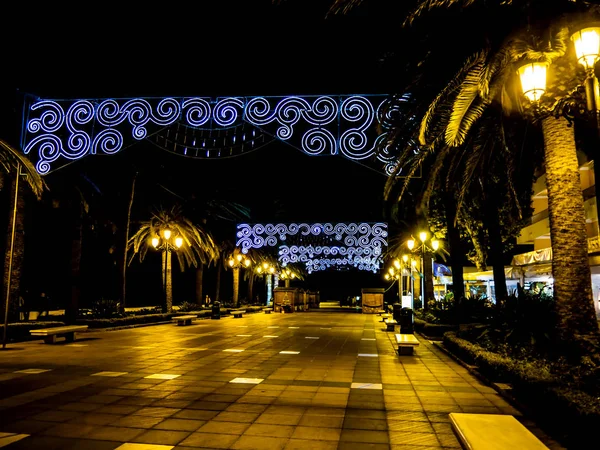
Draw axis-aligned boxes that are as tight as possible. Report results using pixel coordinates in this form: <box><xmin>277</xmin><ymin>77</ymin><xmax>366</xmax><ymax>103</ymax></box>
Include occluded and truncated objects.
<box><xmin>236</xmin><ymin>222</ymin><xmax>388</xmax><ymax>273</ymax></box>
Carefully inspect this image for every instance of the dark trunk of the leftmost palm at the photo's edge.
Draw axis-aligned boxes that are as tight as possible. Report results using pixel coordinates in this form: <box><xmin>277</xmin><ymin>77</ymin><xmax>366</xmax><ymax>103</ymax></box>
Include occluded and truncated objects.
<box><xmin>2</xmin><ymin>173</ymin><xmax>25</xmax><ymax>321</ymax></box>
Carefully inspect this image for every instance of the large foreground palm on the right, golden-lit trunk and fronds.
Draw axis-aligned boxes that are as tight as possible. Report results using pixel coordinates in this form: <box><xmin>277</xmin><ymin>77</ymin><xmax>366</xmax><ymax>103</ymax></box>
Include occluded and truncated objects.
<box><xmin>382</xmin><ymin>0</ymin><xmax>599</xmax><ymax>357</ymax></box>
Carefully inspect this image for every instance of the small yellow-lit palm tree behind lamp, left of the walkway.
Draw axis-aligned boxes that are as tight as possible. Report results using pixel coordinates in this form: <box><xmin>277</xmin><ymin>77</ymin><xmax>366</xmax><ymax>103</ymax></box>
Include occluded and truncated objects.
<box><xmin>127</xmin><ymin>206</ymin><xmax>219</xmax><ymax>312</ymax></box>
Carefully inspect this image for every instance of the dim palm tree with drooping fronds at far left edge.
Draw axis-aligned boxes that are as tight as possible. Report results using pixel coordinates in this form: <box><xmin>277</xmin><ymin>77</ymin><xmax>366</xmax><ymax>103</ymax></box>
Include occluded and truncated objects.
<box><xmin>0</xmin><ymin>139</ymin><xmax>47</xmax><ymax>324</ymax></box>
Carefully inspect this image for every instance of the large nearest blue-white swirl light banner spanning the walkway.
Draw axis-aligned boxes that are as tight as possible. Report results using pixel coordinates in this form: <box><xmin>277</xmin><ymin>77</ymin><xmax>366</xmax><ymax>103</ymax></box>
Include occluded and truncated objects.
<box><xmin>22</xmin><ymin>95</ymin><xmax>390</xmax><ymax>174</ymax></box>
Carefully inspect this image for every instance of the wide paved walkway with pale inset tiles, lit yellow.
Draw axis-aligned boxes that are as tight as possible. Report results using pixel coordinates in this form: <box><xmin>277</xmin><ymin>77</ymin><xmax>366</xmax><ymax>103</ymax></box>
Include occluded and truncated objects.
<box><xmin>0</xmin><ymin>312</ymin><xmax>562</xmax><ymax>450</ymax></box>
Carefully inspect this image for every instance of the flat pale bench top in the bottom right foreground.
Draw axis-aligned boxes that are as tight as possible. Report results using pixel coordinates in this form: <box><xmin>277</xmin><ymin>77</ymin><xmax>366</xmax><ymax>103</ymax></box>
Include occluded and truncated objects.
<box><xmin>449</xmin><ymin>413</ymin><xmax>548</xmax><ymax>450</ymax></box>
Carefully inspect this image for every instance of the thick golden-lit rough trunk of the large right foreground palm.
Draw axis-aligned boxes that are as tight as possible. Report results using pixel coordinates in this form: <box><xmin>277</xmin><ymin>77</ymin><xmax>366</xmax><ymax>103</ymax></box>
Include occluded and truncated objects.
<box><xmin>542</xmin><ymin>117</ymin><xmax>599</xmax><ymax>354</ymax></box>
